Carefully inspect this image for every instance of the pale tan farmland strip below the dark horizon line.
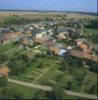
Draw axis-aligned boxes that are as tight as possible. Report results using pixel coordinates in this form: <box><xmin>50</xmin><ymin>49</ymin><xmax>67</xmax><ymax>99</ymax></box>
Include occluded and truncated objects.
<box><xmin>0</xmin><ymin>11</ymin><xmax>96</xmax><ymax>22</ymax></box>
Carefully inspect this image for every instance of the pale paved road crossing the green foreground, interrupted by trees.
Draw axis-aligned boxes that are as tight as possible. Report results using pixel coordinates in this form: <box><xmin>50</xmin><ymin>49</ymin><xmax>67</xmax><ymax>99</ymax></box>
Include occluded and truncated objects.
<box><xmin>8</xmin><ymin>78</ymin><xmax>97</xmax><ymax>100</ymax></box>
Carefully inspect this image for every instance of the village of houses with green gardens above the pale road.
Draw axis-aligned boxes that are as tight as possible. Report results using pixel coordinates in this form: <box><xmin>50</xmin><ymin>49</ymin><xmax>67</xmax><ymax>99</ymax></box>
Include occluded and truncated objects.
<box><xmin>0</xmin><ymin>15</ymin><xmax>98</xmax><ymax>98</ymax></box>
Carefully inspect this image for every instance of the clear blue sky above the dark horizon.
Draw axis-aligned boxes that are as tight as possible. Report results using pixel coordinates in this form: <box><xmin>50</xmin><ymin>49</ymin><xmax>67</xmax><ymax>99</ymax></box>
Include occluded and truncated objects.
<box><xmin>0</xmin><ymin>0</ymin><xmax>97</xmax><ymax>12</ymax></box>
